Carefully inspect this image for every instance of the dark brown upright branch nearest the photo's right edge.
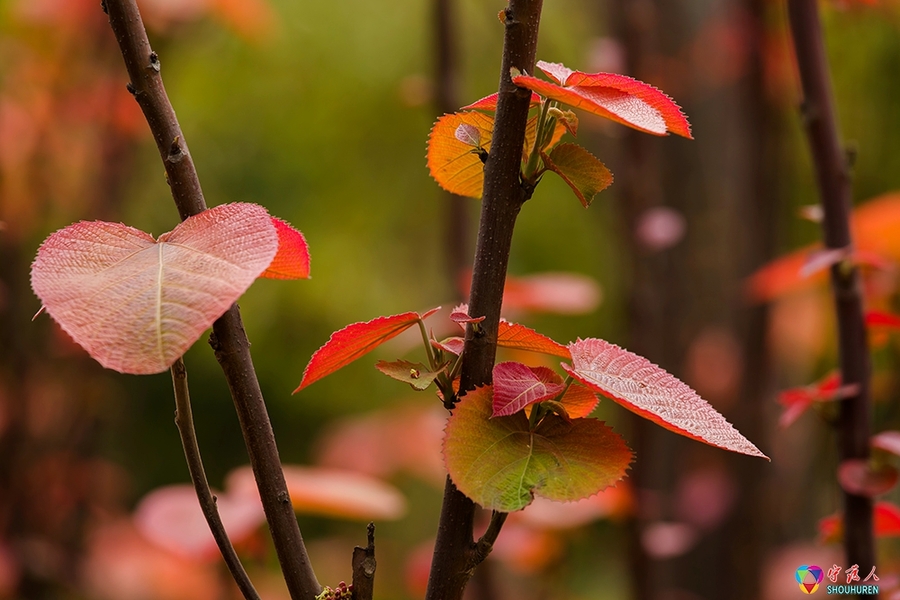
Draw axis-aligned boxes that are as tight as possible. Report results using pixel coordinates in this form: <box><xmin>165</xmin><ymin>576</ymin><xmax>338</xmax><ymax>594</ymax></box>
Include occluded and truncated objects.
<box><xmin>788</xmin><ymin>0</ymin><xmax>875</xmax><ymax>584</ymax></box>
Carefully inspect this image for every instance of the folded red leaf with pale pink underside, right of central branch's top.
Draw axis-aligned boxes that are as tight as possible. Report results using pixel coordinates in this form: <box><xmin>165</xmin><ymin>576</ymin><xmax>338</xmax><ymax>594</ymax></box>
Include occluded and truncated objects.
<box><xmin>513</xmin><ymin>61</ymin><xmax>692</xmax><ymax>139</ymax></box>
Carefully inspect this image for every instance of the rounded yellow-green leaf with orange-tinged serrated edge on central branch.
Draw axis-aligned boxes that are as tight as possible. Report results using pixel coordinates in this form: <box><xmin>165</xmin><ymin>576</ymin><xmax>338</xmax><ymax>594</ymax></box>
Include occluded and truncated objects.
<box><xmin>444</xmin><ymin>386</ymin><xmax>632</xmax><ymax>512</ymax></box>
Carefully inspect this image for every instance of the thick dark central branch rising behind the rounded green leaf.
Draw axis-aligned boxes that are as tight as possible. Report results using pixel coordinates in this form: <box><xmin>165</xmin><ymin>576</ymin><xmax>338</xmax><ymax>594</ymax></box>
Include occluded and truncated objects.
<box><xmin>425</xmin><ymin>0</ymin><xmax>543</xmax><ymax>600</ymax></box>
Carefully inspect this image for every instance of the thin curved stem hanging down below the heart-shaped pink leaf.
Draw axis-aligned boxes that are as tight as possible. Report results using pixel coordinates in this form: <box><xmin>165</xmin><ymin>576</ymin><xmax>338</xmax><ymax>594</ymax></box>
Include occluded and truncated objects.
<box><xmin>171</xmin><ymin>358</ymin><xmax>259</xmax><ymax>600</ymax></box>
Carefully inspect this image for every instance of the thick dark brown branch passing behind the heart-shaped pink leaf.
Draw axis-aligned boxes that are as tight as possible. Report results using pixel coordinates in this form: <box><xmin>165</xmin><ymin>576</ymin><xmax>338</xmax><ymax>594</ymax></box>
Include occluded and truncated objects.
<box><xmin>102</xmin><ymin>0</ymin><xmax>321</xmax><ymax>600</ymax></box>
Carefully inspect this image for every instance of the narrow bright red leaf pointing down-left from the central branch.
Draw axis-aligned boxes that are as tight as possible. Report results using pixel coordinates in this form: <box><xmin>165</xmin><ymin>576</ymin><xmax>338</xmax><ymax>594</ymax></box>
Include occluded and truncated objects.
<box><xmin>293</xmin><ymin>308</ymin><xmax>438</xmax><ymax>394</ymax></box>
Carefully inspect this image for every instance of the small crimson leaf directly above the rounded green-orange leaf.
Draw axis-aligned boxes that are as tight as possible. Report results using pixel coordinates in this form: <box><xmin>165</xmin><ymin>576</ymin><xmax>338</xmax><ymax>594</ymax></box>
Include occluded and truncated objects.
<box><xmin>491</xmin><ymin>362</ymin><xmax>565</xmax><ymax>417</ymax></box>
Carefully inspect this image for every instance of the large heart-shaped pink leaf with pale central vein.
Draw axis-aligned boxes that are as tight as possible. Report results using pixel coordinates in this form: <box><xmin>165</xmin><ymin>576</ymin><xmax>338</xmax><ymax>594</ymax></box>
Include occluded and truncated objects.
<box><xmin>31</xmin><ymin>204</ymin><xmax>278</xmax><ymax>375</ymax></box>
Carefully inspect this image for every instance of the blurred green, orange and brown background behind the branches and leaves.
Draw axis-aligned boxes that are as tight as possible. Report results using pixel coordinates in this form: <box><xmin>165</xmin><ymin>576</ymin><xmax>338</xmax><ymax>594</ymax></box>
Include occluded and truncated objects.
<box><xmin>0</xmin><ymin>0</ymin><xmax>900</xmax><ymax>600</ymax></box>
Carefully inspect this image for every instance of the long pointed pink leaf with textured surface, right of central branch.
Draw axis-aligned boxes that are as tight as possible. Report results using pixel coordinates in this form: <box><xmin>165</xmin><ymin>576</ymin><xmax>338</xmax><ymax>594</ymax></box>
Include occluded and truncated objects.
<box><xmin>563</xmin><ymin>338</ymin><xmax>768</xmax><ymax>458</ymax></box>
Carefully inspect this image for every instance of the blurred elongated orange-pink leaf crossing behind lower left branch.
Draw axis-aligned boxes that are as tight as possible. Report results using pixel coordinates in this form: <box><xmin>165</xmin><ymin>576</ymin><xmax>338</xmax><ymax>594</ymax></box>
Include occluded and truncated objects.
<box><xmin>227</xmin><ymin>465</ymin><xmax>406</xmax><ymax>521</ymax></box>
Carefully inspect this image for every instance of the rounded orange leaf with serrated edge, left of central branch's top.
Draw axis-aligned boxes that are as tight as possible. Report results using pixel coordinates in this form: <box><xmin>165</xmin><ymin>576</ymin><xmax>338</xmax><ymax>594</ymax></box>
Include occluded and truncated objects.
<box><xmin>427</xmin><ymin>112</ymin><xmax>494</xmax><ymax>198</ymax></box>
